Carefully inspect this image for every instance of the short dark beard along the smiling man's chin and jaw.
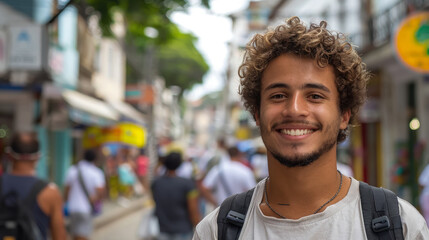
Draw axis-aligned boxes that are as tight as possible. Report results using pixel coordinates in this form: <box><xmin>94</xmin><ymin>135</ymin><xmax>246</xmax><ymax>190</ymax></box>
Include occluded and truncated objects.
<box><xmin>270</xmin><ymin>138</ymin><xmax>337</xmax><ymax>167</ymax></box>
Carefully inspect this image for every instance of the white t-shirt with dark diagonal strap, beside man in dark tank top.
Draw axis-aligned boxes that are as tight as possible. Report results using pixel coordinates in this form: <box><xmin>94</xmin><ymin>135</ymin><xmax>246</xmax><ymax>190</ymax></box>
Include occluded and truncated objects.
<box><xmin>65</xmin><ymin>161</ymin><xmax>105</xmax><ymax>214</ymax></box>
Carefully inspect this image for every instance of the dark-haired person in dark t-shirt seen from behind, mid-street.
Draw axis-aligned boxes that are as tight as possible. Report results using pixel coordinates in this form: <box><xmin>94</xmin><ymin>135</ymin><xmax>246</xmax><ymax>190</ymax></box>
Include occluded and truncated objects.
<box><xmin>152</xmin><ymin>151</ymin><xmax>201</xmax><ymax>240</ymax></box>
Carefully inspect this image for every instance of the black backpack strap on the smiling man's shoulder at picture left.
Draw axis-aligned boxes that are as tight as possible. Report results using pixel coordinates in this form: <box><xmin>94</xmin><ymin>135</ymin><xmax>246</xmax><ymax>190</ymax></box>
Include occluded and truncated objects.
<box><xmin>217</xmin><ymin>188</ymin><xmax>255</xmax><ymax>240</ymax></box>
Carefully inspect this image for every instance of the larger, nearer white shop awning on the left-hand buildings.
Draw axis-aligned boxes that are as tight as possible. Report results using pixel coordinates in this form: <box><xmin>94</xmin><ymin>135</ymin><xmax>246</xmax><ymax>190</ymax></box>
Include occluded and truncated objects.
<box><xmin>62</xmin><ymin>90</ymin><xmax>120</xmax><ymax>126</ymax></box>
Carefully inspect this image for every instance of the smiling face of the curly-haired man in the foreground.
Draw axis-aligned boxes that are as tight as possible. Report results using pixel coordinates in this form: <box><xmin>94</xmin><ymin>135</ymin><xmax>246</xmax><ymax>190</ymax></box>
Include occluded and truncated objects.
<box><xmin>255</xmin><ymin>54</ymin><xmax>350</xmax><ymax>167</ymax></box>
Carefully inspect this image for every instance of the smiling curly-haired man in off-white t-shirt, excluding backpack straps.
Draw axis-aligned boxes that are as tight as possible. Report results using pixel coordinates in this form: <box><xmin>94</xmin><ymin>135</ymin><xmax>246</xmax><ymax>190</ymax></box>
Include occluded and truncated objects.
<box><xmin>194</xmin><ymin>17</ymin><xmax>429</xmax><ymax>240</ymax></box>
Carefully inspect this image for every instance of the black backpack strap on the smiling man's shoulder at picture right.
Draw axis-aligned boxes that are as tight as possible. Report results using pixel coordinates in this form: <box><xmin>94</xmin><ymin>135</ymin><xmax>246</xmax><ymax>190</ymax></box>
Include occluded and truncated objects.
<box><xmin>359</xmin><ymin>182</ymin><xmax>404</xmax><ymax>240</ymax></box>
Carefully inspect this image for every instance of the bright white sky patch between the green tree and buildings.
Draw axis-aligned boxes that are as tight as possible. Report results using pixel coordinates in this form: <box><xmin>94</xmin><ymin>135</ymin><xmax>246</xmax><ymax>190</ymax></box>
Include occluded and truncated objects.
<box><xmin>172</xmin><ymin>0</ymin><xmax>249</xmax><ymax>100</ymax></box>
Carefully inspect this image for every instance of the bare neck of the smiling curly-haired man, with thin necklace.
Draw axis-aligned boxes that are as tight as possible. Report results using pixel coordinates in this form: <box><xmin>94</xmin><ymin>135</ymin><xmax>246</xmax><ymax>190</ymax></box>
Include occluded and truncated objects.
<box><xmin>261</xmin><ymin>152</ymin><xmax>351</xmax><ymax>219</ymax></box>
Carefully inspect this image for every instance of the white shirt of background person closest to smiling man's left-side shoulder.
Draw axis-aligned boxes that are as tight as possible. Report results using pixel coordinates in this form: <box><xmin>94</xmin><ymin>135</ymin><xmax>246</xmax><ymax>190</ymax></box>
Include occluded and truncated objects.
<box><xmin>203</xmin><ymin>161</ymin><xmax>256</xmax><ymax>205</ymax></box>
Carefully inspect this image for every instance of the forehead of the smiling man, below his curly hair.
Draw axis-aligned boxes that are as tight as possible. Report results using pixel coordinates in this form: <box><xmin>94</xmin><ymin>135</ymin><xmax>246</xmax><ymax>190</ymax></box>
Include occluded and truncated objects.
<box><xmin>261</xmin><ymin>54</ymin><xmax>336</xmax><ymax>91</ymax></box>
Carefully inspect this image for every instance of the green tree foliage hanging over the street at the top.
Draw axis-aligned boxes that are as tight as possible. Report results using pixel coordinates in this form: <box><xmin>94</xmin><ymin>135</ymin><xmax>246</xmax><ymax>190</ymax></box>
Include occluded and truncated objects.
<box><xmin>85</xmin><ymin>0</ymin><xmax>209</xmax><ymax>93</ymax></box>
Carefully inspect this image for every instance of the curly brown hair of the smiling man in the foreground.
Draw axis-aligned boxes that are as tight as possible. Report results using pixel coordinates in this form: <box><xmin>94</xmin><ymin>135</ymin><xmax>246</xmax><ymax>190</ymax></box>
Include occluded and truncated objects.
<box><xmin>238</xmin><ymin>17</ymin><xmax>370</xmax><ymax>142</ymax></box>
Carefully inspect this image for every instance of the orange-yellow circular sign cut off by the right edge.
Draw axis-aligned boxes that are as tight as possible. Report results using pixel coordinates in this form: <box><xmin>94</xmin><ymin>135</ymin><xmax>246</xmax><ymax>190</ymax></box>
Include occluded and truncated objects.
<box><xmin>395</xmin><ymin>12</ymin><xmax>429</xmax><ymax>73</ymax></box>
